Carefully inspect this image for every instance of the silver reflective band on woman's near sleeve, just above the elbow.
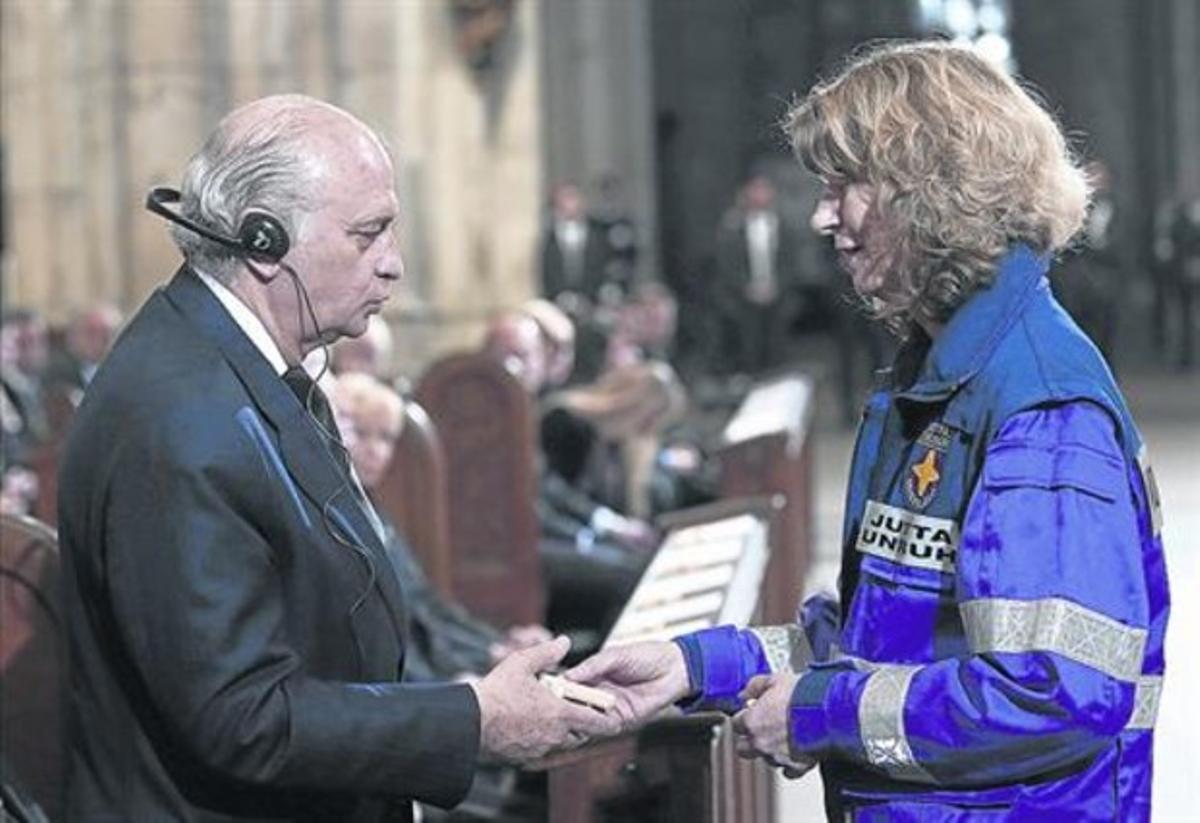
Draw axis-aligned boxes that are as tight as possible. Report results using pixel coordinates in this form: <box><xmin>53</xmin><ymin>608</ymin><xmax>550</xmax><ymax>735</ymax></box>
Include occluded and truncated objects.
<box><xmin>959</xmin><ymin>597</ymin><xmax>1146</xmax><ymax>683</ymax></box>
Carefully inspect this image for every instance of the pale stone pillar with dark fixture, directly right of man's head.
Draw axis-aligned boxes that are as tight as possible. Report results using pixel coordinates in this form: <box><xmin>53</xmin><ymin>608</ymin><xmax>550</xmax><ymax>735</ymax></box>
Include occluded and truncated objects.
<box><xmin>394</xmin><ymin>0</ymin><xmax>541</xmax><ymax>374</ymax></box>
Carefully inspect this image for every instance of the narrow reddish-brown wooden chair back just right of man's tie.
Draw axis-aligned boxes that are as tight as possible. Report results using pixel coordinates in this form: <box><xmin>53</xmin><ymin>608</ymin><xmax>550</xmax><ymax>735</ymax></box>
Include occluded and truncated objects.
<box><xmin>374</xmin><ymin>400</ymin><xmax>454</xmax><ymax>595</ymax></box>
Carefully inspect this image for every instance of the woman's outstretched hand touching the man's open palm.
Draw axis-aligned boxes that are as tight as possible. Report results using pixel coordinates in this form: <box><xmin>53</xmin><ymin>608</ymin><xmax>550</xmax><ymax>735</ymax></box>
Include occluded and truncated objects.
<box><xmin>564</xmin><ymin>641</ymin><xmax>690</xmax><ymax>731</ymax></box>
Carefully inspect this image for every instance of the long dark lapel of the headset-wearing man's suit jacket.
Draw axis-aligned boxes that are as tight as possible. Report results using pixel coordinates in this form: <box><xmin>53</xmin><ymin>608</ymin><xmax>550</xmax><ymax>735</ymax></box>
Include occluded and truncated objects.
<box><xmin>159</xmin><ymin>266</ymin><xmax>403</xmax><ymax>614</ymax></box>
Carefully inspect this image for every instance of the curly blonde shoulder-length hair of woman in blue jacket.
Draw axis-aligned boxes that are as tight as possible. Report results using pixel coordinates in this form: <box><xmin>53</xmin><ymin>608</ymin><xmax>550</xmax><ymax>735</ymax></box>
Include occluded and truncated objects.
<box><xmin>785</xmin><ymin>42</ymin><xmax>1090</xmax><ymax>329</ymax></box>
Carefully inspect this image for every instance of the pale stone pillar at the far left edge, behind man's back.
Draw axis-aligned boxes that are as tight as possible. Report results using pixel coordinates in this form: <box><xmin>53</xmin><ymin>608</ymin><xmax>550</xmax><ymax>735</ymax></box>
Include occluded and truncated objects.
<box><xmin>0</xmin><ymin>0</ymin><xmax>121</xmax><ymax>320</ymax></box>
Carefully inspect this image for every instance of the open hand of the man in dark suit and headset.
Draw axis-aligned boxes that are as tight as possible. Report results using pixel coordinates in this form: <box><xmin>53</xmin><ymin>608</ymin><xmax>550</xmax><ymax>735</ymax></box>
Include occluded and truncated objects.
<box><xmin>472</xmin><ymin>637</ymin><xmax>619</xmax><ymax>765</ymax></box>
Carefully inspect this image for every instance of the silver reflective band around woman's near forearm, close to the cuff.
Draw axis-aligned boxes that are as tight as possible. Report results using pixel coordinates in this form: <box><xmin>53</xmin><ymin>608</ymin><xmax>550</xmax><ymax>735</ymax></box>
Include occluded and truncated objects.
<box><xmin>858</xmin><ymin>663</ymin><xmax>937</xmax><ymax>783</ymax></box>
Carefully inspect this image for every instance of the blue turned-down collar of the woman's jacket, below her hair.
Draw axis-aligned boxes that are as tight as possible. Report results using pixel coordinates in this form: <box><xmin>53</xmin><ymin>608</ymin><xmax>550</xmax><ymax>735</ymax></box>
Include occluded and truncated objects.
<box><xmin>896</xmin><ymin>245</ymin><xmax>1049</xmax><ymax>403</ymax></box>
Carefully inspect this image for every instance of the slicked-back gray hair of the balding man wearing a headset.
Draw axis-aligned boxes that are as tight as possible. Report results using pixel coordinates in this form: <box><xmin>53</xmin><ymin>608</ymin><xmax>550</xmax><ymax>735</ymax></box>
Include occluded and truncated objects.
<box><xmin>172</xmin><ymin>104</ymin><xmax>322</xmax><ymax>283</ymax></box>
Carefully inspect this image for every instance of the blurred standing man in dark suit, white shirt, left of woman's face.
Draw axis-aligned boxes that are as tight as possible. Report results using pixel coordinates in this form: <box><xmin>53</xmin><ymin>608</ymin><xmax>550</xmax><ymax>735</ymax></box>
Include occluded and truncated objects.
<box><xmin>714</xmin><ymin>175</ymin><xmax>798</xmax><ymax>374</ymax></box>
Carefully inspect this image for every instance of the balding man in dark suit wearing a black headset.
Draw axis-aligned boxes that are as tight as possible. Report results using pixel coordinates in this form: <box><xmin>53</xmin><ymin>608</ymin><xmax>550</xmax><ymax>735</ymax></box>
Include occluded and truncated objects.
<box><xmin>59</xmin><ymin>96</ymin><xmax>608</xmax><ymax>821</ymax></box>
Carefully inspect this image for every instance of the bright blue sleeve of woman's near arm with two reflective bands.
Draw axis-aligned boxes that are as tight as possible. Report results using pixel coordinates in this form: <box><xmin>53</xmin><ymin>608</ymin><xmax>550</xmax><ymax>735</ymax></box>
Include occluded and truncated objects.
<box><xmin>790</xmin><ymin>402</ymin><xmax>1148</xmax><ymax>786</ymax></box>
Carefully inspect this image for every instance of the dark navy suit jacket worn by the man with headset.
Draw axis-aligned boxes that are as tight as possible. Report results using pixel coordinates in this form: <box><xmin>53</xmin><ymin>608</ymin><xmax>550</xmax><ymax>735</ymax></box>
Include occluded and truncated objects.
<box><xmin>59</xmin><ymin>269</ymin><xmax>479</xmax><ymax>821</ymax></box>
